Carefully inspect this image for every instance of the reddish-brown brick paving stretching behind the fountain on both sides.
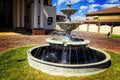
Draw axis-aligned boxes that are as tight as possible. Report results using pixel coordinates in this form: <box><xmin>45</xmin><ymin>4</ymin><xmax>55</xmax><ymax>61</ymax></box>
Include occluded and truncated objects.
<box><xmin>0</xmin><ymin>33</ymin><xmax>120</xmax><ymax>53</ymax></box>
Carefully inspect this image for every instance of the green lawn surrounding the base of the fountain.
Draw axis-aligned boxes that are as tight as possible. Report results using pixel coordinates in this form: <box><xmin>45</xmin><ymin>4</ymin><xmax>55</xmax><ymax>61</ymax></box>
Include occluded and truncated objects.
<box><xmin>0</xmin><ymin>47</ymin><xmax>120</xmax><ymax>80</ymax></box>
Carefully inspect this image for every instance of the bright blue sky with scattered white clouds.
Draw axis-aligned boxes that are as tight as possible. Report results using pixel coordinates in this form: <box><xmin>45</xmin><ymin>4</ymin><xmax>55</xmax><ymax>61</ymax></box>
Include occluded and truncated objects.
<box><xmin>52</xmin><ymin>0</ymin><xmax>120</xmax><ymax>20</ymax></box>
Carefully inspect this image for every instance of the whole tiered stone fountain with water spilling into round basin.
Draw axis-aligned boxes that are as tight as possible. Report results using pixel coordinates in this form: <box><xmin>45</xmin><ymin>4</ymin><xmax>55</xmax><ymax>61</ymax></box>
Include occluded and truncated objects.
<box><xmin>27</xmin><ymin>2</ymin><xmax>110</xmax><ymax>76</ymax></box>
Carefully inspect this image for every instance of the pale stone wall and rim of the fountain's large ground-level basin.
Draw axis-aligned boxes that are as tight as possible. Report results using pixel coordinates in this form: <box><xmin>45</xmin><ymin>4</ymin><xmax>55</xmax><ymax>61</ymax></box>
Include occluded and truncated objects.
<box><xmin>27</xmin><ymin>44</ymin><xmax>110</xmax><ymax>76</ymax></box>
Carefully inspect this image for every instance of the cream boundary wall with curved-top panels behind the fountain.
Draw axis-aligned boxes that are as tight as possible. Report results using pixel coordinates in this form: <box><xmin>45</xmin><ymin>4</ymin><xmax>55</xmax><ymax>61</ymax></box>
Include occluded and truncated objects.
<box><xmin>56</xmin><ymin>24</ymin><xmax>120</xmax><ymax>35</ymax></box>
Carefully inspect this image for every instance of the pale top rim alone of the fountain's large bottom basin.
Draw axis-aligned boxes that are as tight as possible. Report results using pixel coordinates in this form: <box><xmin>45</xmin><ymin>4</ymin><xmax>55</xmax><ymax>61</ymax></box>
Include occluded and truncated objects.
<box><xmin>27</xmin><ymin>44</ymin><xmax>110</xmax><ymax>67</ymax></box>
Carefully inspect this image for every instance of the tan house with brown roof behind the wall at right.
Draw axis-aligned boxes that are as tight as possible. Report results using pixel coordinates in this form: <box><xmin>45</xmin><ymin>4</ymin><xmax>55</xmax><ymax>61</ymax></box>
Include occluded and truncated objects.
<box><xmin>84</xmin><ymin>6</ymin><xmax>120</xmax><ymax>33</ymax></box>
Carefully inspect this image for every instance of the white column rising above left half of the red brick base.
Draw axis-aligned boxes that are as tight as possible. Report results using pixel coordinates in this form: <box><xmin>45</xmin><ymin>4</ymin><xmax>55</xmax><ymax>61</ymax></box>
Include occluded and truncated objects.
<box><xmin>33</xmin><ymin>0</ymin><xmax>38</xmax><ymax>29</ymax></box>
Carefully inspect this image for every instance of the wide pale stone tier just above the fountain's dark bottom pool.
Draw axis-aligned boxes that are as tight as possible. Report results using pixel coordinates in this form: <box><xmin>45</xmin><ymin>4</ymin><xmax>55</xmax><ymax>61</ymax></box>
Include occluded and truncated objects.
<box><xmin>46</xmin><ymin>38</ymin><xmax>90</xmax><ymax>49</ymax></box>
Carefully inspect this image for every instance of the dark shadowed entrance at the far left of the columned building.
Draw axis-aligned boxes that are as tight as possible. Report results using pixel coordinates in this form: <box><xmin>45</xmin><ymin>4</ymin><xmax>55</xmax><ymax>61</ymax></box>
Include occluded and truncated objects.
<box><xmin>0</xmin><ymin>0</ymin><xmax>13</xmax><ymax>31</ymax></box>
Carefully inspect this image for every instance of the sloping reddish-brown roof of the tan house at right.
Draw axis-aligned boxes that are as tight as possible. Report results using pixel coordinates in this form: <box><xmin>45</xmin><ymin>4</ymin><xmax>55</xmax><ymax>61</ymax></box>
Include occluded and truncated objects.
<box><xmin>86</xmin><ymin>6</ymin><xmax>120</xmax><ymax>16</ymax></box>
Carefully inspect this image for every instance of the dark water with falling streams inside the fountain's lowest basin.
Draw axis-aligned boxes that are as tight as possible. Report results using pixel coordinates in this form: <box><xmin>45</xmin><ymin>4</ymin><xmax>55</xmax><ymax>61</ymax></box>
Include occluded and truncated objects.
<box><xmin>31</xmin><ymin>46</ymin><xmax>105</xmax><ymax>64</ymax></box>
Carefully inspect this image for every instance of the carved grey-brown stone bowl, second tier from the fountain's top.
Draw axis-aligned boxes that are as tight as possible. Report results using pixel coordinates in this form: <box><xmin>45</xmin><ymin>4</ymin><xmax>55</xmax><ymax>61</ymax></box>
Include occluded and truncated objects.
<box><xmin>57</xmin><ymin>22</ymin><xmax>81</xmax><ymax>31</ymax></box>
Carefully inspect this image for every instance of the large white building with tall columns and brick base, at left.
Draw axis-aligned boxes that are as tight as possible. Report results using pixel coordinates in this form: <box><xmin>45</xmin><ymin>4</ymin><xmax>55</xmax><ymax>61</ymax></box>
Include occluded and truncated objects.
<box><xmin>0</xmin><ymin>0</ymin><xmax>56</xmax><ymax>34</ymax></box>
